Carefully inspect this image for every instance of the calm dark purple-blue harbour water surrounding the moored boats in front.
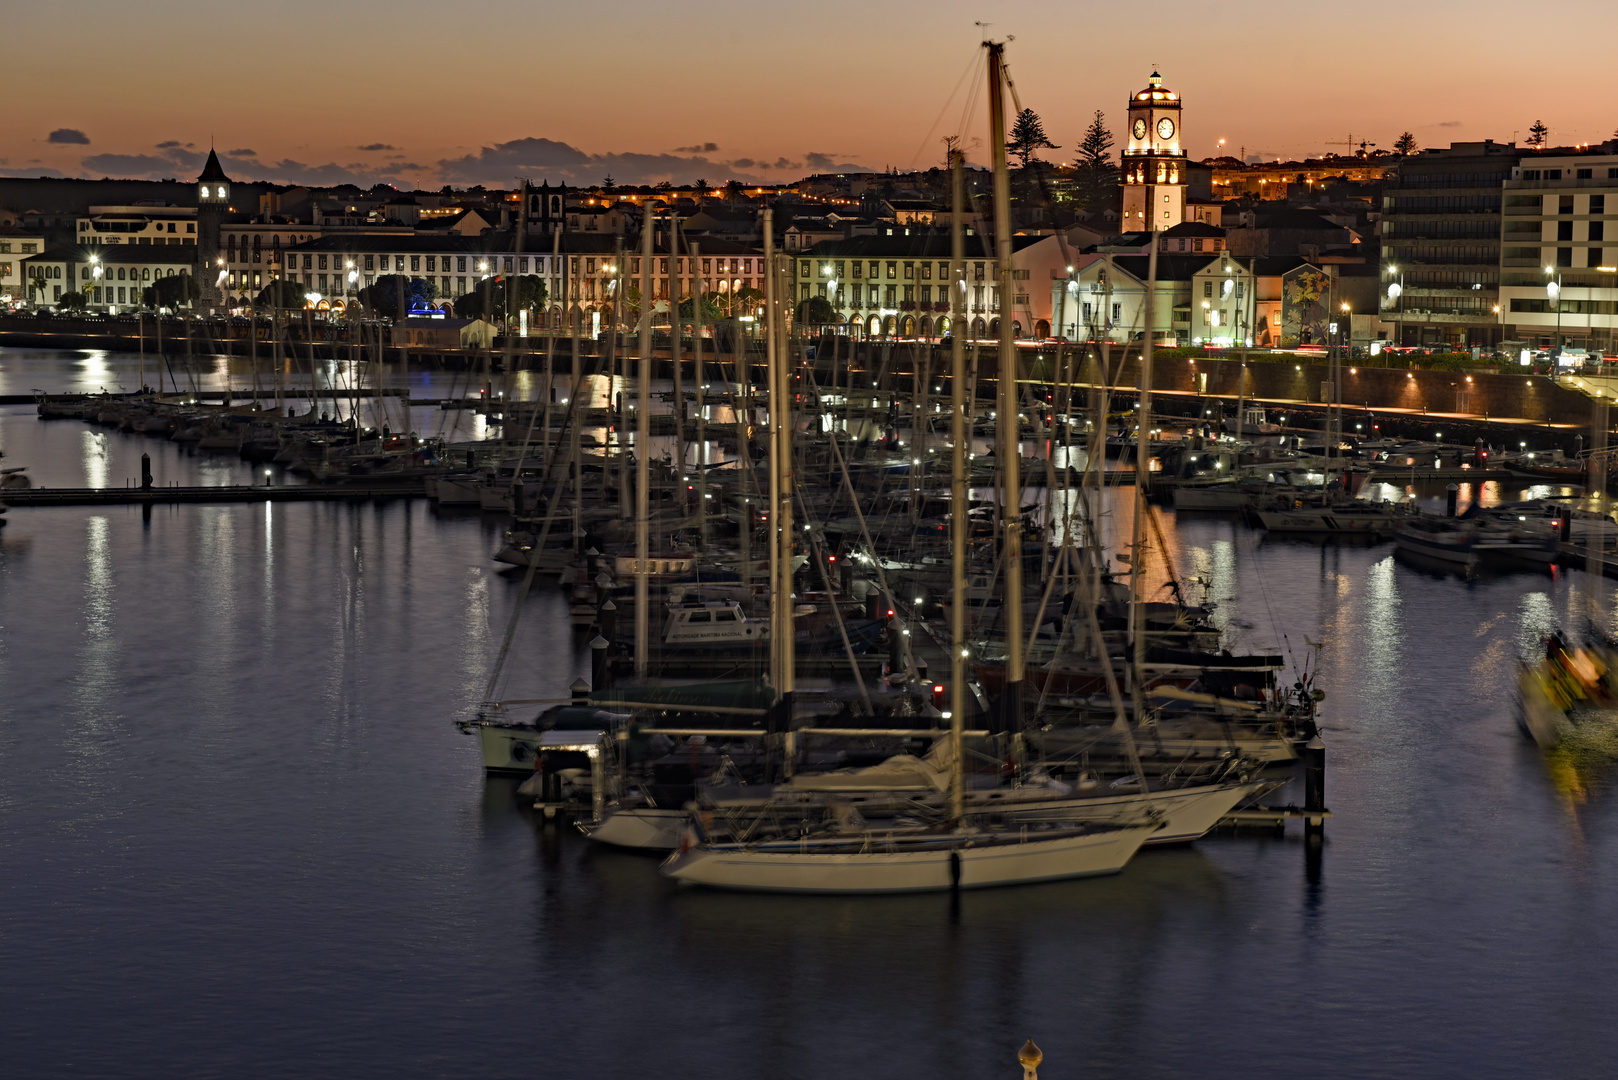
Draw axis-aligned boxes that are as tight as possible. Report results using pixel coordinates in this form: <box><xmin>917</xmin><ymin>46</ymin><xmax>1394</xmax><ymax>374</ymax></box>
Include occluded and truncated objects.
<box><xmin>0</xmin><ymin>390</ymin><xmax>1618</xmax><ymax>1078</ymax></box>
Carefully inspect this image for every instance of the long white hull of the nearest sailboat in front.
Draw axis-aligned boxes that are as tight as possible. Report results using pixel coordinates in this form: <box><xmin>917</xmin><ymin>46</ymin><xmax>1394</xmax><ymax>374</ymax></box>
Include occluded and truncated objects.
<box><xmin>662</xmin><ymin>824</ymin><xmax>1157</xmax><ymax>894</ymax></box>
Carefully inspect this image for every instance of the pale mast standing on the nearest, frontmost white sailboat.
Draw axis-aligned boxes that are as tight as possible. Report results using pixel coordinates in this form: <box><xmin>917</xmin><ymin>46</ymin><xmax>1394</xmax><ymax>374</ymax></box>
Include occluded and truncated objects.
<box><xmin>944</xmin><ymin>151</ymin><xmax>968</xmax><ymax>821</ymax></box>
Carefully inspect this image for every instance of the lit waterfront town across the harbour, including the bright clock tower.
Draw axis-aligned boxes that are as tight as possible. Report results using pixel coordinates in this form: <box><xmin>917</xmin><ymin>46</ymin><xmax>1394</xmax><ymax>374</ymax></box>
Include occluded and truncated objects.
<box><xmin>0</xmin><ymin>73</ymin><xmax>1618</xmax><ymax>351</ymax></box>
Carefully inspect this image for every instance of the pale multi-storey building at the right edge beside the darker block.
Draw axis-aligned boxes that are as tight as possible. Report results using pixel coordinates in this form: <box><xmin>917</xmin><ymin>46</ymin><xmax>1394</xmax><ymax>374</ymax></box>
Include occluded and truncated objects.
<box><xmin>1500</xmin><ymin>154</ymin><xmax>1618</xmax><ymax>353</ymax></box>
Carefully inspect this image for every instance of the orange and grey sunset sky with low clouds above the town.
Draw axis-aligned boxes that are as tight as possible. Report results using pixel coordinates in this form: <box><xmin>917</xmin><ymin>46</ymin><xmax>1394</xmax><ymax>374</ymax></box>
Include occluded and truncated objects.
<box><xmin>12</xmin><ymin>0</ymin><xmax>1618</xmax><ymax>188</ymax></box>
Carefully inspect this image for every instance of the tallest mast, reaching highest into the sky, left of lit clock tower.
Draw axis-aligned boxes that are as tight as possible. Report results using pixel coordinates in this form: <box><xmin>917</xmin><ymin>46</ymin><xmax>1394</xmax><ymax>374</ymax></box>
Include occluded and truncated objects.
<box><xmin>984</xmin><ymin>42</ymin><xmax>1023</xmax><ymax>732</ymax></box>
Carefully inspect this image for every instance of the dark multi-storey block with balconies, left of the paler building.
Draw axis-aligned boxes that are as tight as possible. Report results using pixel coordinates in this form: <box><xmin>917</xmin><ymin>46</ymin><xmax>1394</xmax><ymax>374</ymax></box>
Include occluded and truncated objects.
<box><xmin>1380</xmin><ymin>139</ymin><xmax>1523</xmax><ymax>348</ymax></box>
